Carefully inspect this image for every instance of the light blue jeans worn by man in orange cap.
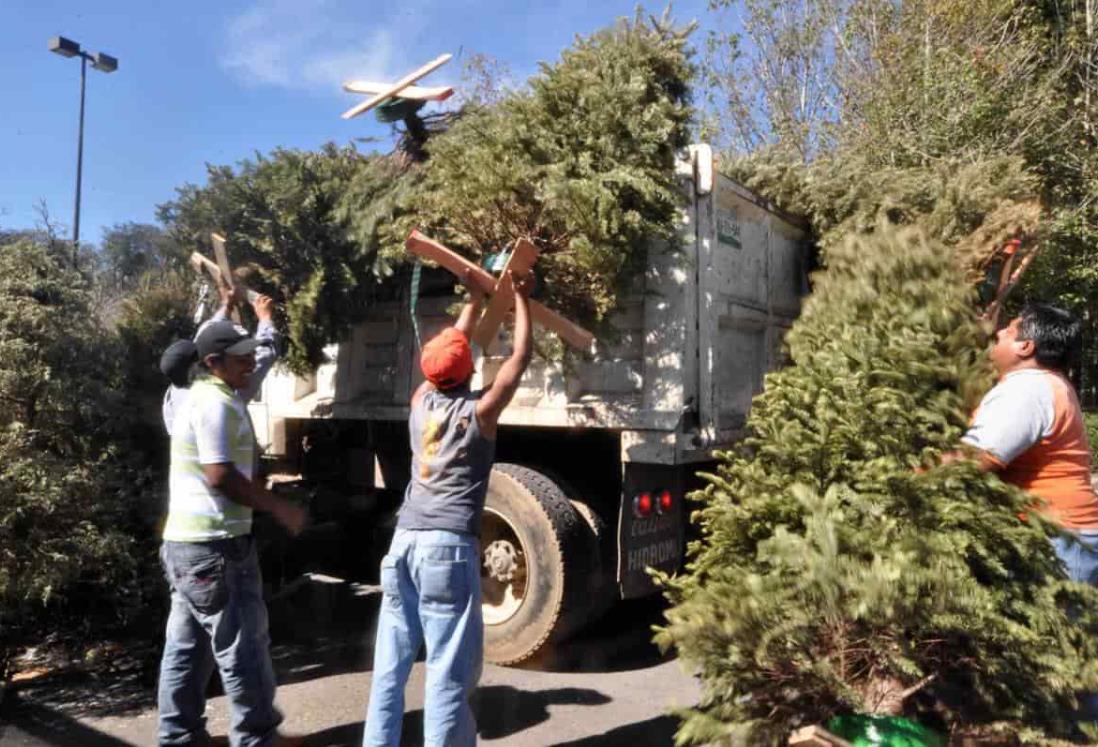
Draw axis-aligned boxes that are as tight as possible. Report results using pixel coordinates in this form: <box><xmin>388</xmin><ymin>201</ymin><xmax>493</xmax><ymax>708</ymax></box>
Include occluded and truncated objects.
<box><xmin>362</xmin><ymin>529</ymin><xmax>484</xmax><ymax>747</ymax></box>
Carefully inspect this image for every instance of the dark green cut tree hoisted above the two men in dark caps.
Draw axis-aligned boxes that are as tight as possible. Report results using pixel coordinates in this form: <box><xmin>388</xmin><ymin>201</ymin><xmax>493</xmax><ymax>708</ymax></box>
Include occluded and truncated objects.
<box><xmin>152</xmin><ymin>144</ymin><xmax>377</xmax><ymax>369</ymax></box>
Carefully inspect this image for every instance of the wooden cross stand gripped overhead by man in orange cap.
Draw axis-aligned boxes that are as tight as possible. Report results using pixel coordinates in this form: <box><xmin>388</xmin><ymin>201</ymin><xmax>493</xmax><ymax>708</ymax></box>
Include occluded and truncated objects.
<box><xmin>404</xmin><ymin>231</ymin><xmax>595</xmax><ymax>350</ymax></box>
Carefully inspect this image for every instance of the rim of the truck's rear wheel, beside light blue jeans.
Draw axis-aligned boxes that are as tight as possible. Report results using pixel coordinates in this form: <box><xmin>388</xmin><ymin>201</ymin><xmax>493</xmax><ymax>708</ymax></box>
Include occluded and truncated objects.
<box><xmin>481</xmin><ymin>508</ymin><xmax>529</xmax><ymax>625</ymax></box>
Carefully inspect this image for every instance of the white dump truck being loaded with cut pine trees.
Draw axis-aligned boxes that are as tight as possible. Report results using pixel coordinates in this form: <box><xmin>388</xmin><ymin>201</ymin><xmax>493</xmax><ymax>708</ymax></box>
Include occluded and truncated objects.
<box><xmin>250</xmin><ymin>145</ymin><xmax>809</xmax><ymax>665</ymax></box>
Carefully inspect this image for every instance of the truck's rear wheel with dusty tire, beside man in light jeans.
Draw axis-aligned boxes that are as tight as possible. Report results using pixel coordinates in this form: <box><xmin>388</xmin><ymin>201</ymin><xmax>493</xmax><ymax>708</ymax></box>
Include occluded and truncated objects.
<box><xmin>481</xmin><ymin>464</ymin><xmax>598</xmax><ymax>665</ymax></box>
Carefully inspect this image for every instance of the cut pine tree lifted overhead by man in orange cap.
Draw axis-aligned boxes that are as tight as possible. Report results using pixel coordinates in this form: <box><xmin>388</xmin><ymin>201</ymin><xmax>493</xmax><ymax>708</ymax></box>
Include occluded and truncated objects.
<box><xmin>386</xmin><ymin>12</ymin><xmax>694</xmax><ymax>322</ymax></box>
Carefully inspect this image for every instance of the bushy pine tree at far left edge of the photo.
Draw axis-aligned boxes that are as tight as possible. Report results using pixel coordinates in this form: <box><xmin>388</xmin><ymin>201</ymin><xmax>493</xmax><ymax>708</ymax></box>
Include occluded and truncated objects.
<box><xmin>0</xmin><ymin>239</ymin><xmax>149</xmax><ymax>669</ymax></box>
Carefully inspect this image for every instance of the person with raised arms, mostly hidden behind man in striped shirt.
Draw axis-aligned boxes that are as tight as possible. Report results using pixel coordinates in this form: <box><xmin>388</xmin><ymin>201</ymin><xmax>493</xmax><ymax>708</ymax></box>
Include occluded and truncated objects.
<box><xmin>160</xmin><ymin>278</ymin><xmax>282</xmax><ymax>436</ymax></box>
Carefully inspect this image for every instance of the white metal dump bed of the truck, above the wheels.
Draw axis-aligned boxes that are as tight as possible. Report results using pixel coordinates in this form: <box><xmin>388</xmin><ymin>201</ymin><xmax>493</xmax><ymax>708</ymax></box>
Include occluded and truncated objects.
<box><xmin>251</xmin><ymin>146</ymin><xmax>806</xmax><ymax>465</ymax></box>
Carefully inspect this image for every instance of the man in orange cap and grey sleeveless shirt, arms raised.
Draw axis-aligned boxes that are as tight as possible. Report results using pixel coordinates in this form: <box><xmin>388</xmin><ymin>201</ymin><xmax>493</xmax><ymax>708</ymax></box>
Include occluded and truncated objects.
<box><xmin>362</xmin><ymin>272</ymin><xmax>533</xmax><ymax>747</ymax></box>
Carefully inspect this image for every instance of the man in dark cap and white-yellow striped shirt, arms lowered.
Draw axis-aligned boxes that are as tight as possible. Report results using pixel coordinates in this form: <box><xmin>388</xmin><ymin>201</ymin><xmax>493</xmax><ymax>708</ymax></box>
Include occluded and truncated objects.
<box><xmin>158</xmin><ymin>321</ymin><xmax>305</xmax><ymax>747</ymax></box>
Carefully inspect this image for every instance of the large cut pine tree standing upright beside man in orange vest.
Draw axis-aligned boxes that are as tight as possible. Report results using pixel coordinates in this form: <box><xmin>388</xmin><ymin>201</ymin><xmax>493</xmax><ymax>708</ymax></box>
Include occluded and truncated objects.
<box><xmin>658</xmin><ymin>226</ymin><xmax>1098</xmax><ymax>744</ymax></box>
